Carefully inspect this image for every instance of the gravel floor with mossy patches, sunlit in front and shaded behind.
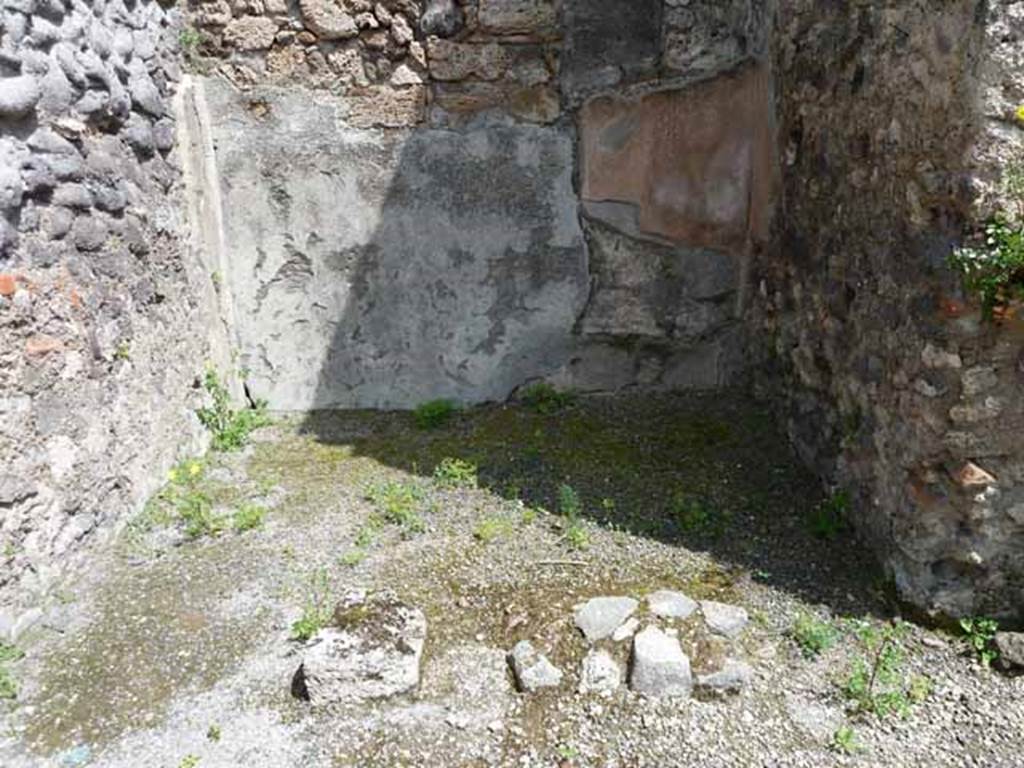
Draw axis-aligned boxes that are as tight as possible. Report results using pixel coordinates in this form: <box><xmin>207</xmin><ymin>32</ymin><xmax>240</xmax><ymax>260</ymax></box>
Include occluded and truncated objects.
<box><xmin>0</xmin><ymin>393</ymin><xmax>1024</xmax><ymax>768</ymax></box>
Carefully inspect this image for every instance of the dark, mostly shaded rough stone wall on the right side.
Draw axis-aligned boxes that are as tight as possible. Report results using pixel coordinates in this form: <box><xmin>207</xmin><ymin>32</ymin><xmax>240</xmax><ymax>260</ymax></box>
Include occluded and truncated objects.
<box><xmin>755</xmin><ymin>0</ymin><xmax>1024</xmax><ymax>615</ymax></box>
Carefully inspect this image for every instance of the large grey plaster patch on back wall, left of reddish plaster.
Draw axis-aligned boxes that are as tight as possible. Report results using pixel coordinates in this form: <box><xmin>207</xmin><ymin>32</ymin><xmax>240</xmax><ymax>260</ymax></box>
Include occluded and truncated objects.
<box><xmin>192</xmin><ymin>80</ymin><xmax>590</xmax><ymax>410</ymax></box>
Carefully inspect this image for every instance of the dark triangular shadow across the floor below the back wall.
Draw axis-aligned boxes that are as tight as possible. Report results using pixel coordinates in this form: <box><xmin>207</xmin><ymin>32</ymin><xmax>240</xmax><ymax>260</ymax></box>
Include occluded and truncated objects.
<box><xmin>302</xmin><ymin>391</ymin><xmax>891</xmax><ymax>615</ymax></box>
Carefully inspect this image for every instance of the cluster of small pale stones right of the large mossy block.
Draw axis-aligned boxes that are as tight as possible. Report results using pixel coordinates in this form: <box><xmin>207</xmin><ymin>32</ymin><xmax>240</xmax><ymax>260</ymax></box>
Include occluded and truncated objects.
<box><xmin>509</xmin><ymin>590</ymin><xmax>754</xmax><ymax>697</ymax></box>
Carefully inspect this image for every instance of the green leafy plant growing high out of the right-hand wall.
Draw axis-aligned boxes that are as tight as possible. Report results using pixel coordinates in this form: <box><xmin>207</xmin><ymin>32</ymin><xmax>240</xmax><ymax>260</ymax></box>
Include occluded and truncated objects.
<box><xmin>949</xmin><ymin>214</ymin><xmax>1024</xmax><ymax>317</ymax></box>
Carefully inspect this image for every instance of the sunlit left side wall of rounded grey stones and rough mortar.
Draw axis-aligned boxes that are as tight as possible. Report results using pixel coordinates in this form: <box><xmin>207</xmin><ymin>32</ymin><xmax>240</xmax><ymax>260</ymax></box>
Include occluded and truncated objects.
<box><xmin>0</xmin><ymin>0</ymin><xmax>223</xmax><ymax>637</ymax></box>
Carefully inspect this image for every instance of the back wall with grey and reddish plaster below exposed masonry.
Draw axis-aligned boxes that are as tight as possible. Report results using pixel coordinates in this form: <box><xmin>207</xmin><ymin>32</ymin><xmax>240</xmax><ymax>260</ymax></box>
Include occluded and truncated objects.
<box><xmin>189</xmin><ymin>0</ymin><xmax>775</xmax><ymax>410</ymax></box>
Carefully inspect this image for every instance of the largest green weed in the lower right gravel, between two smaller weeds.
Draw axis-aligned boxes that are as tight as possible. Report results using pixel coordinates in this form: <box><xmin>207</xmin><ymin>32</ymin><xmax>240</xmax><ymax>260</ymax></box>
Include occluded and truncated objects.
<box><xmin>843</xmin><ymin>621</ymin><xmax>922</xmax><ymax>717</ymax></box>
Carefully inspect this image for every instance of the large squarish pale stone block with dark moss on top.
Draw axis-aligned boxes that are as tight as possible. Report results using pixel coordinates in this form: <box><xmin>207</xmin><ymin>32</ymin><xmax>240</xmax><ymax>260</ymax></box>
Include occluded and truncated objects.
<box><xmin>292</xmin><ymin>592</ymin><xmax>427</xmax><ymax>706</ymax></box>
